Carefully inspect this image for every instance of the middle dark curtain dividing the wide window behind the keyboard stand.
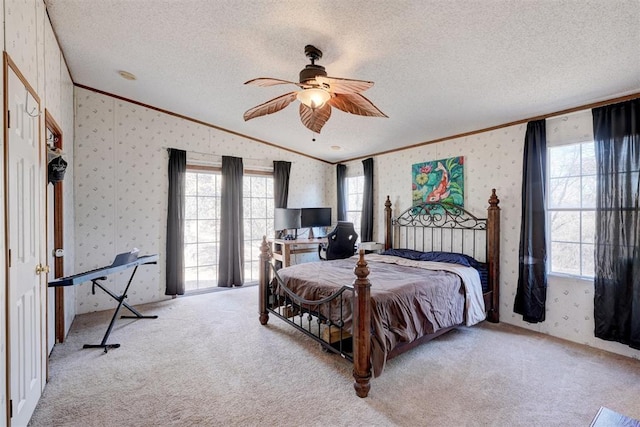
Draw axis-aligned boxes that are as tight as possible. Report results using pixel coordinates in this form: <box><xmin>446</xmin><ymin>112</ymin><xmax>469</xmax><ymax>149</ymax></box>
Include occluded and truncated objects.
<box><xmin>218</xmin><ymin>156</ymin><xmax>244</xmax><ymax>287</ymax></box>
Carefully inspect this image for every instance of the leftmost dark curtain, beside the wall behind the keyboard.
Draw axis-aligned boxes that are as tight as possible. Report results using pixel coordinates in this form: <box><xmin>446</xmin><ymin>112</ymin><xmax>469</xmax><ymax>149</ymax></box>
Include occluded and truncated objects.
<box><xmin>165</xmin><ymin>148</ymin><xmax>187</xmax><ymax>295</ymax></box>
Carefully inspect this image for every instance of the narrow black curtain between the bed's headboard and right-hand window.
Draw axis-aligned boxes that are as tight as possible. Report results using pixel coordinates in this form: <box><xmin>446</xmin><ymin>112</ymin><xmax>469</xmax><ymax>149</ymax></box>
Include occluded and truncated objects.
<box><xmin>513</xmin><ymin>120</ymin><xmax>547</xmax><ymax>323</ymax></box>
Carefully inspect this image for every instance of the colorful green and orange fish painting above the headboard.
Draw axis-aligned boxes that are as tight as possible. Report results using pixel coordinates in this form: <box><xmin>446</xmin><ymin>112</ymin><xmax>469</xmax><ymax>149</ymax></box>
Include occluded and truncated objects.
<box><xmin>411</xmin><ymin>156</ymin><xmax>464</xmax><ymax>206</ymax></box>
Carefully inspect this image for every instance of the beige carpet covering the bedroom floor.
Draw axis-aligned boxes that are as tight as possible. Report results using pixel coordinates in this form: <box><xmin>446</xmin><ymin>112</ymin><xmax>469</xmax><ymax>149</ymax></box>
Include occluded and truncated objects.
<box><xmin>30</xmin><ymin>287</ymin><xmax>640</xmax><ymax>427</ymax></box>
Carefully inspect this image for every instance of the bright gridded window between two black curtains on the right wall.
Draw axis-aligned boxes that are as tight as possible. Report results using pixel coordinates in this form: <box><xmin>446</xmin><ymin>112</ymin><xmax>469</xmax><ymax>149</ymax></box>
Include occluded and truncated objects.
<box><xmin>547</xmin><ymin>141</ymin><xmax>597</xmax><ymax>279</ymax></box>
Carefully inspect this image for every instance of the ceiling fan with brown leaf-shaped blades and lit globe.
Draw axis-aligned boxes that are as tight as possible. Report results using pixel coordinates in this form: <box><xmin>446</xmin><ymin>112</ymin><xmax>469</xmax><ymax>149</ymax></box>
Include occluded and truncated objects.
<box><xmin>244</xmin><ymin>45</ymin><xmax>387</xmax><ymax>133</ymax></box>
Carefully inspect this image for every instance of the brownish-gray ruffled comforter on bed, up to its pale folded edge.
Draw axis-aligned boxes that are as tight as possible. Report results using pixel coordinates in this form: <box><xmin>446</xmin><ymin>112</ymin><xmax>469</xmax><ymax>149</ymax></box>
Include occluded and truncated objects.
<box><xmin>278</xmin><ymin>258</ymin><xmax>465</xmax><ymax>376</ymax></box>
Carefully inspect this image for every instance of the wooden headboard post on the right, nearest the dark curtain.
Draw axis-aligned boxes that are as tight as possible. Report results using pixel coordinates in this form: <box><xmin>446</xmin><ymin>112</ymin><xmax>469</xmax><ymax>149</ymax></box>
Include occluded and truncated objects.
<box><xmin>487</xmin><ymin>188</ymin><xmax>500</xmax><ymax>323</ymax></box>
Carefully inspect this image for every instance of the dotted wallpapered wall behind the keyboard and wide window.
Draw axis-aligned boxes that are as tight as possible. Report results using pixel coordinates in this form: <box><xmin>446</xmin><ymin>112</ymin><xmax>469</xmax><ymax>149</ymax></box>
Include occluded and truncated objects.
<box><xmin>75</xmin><ymin>88</ymin><xmax>331</xmax><ymax>313</ymax></box>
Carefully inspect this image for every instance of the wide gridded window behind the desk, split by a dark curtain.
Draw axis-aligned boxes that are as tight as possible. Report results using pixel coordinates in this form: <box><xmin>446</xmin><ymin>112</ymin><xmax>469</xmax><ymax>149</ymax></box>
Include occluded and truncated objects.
<box><xmin>184</xmin><ymin>168</ymin><xmax>274</xmax><ymax>292</ymax></box>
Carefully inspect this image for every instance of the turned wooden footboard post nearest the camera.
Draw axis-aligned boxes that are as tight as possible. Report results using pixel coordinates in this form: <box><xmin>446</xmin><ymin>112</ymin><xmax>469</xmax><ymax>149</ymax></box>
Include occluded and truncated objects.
<box><xmin>353</xmin><ymin>249</ymin><xmax>371</xmax><ymax>397</ymax></box>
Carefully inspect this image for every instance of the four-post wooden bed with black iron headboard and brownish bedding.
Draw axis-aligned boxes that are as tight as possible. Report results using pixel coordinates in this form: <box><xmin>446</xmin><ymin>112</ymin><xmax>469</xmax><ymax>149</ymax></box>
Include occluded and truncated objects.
<box><xmin>259</xmin><ymin>189</ymin><xmax>500</xmax><ymax>397</ymax></box>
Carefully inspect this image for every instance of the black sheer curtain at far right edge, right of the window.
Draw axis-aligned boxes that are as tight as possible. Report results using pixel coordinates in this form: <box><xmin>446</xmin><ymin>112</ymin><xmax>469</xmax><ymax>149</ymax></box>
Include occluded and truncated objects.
<box><xmin>593</xmin><ymin>99</ymin><xmax>640</xmax><ymax>349</ymax></box>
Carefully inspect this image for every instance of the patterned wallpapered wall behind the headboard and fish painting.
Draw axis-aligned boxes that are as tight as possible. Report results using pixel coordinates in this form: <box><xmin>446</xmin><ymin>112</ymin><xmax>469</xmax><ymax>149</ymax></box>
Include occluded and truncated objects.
<box><xmin>347</xmin><ymin>111</ymin><xmax>640</xmax><ymax>359</ymax></box>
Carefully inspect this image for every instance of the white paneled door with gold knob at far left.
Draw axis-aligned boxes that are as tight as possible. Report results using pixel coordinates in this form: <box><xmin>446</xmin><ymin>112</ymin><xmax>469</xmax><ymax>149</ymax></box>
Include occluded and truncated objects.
<box><xmin>7</xmin><ymin>67</ymin><xmax>46</xmax><ymax>426</ymax></box>
